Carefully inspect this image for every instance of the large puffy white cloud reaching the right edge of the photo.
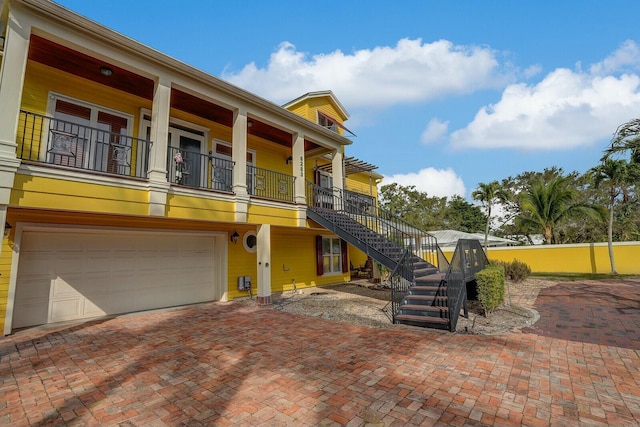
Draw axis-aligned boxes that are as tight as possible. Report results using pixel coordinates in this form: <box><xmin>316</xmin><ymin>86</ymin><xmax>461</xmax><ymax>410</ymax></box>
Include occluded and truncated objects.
<box><xmin>450</xmin><ymin>43</ymin><xmax>640</xmax><ymax>150</ymax></box>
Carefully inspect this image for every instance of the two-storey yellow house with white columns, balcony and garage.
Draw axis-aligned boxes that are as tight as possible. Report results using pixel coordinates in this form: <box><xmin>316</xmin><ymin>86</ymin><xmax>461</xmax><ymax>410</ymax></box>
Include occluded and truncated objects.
<box><xmin>0</xmin><ymin>0</ymin><xmax>390</xmax><ymax>335</ymax></box>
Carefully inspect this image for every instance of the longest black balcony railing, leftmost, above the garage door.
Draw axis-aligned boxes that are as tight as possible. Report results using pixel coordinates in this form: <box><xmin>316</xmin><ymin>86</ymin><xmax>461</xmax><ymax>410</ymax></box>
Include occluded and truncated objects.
<box><xmin>16</xmin><ymin>111</ymin><xmax>151</xmax><ymax>178</ymax></box>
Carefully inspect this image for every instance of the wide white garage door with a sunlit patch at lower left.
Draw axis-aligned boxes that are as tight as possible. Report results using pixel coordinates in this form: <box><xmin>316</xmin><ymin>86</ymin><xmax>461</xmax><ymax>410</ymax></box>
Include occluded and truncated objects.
<box><xmin>13</xmin><ymin>230</ymin><xmax>216</xmax><ymax>328</ymax></box>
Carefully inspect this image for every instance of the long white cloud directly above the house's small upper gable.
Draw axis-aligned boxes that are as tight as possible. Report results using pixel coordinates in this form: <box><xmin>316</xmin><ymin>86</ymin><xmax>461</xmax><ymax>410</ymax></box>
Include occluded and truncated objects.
<box><xmin>222</xmin><ymin>39</ymin><xmax>504</xmax><ymax>108</ymax></box>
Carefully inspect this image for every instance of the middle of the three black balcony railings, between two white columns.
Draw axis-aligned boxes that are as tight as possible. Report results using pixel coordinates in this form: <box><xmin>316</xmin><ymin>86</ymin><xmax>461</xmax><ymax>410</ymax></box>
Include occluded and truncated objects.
<box><xmin>167</xmin><ymin>147</ymin><xmax>234</xmax><ymax>193</ymax></box>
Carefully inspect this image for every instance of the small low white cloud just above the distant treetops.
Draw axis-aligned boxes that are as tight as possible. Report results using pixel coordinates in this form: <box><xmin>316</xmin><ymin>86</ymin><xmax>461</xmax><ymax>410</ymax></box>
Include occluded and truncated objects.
<box><xmin>382</xmin><ymin>168</ymin><xmax>467</xmax><ymax>197</ymax></box>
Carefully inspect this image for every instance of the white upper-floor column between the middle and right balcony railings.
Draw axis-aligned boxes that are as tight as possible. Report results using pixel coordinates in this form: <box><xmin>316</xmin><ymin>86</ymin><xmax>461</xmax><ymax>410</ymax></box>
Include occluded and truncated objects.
<box><xmin>231</xmin><ymin>110</ymin><xmax>249</xmax><ymax>222</ymax></box>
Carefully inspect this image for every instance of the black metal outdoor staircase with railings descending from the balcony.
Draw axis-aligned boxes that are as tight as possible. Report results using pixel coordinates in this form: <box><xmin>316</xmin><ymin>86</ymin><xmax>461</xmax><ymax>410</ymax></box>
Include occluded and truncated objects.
<box><xmin>307</xmin><ymin>183</ymin><xmax>466</xmax><ymax>331</ymax></box>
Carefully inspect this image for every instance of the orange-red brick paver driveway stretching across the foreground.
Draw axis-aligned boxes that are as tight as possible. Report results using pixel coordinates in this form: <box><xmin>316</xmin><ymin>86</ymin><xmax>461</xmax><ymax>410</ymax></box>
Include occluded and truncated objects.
<box><xmin>0</xmin><ymin>284</ymin><xmax>640</xmax><ymax>427</ymax></box>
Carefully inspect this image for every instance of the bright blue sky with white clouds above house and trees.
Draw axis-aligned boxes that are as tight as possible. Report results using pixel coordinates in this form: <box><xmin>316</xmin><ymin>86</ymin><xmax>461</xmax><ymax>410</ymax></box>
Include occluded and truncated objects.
<box><xmin>58</xmin><ymin>0</ymin><xmax>640</xmax><ymax>198</ymax></box>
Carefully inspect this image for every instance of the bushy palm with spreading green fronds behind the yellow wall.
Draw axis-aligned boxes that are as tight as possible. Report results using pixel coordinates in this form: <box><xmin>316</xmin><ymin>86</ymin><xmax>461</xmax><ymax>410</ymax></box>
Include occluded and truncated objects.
<box><xmin>517</xmin><ymin>176</ymin><xmax>602</xmax><ymax>244</ymax></box>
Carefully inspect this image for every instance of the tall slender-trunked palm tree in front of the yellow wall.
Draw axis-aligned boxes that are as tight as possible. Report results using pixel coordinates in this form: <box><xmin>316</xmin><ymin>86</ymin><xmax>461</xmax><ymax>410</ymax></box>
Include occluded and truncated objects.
<box><xmin>589</xmin><ymin>158</ymin><xmax>639</xmax><ymax>274</ymax></box>
